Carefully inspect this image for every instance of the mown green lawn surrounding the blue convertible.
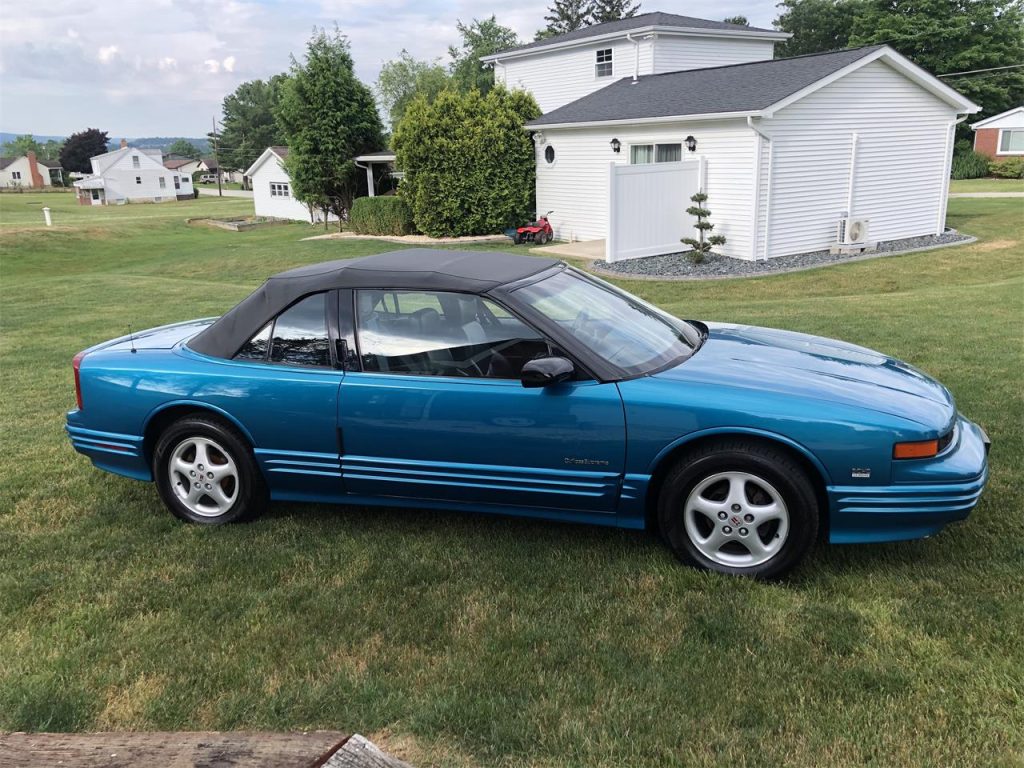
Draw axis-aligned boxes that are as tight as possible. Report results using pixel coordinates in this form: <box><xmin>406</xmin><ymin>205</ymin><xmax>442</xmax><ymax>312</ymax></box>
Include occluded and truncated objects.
<box><xmin>0</xmin><ymin>195</ymin><xmax>1024</xmax><ymax>767</ymax></box>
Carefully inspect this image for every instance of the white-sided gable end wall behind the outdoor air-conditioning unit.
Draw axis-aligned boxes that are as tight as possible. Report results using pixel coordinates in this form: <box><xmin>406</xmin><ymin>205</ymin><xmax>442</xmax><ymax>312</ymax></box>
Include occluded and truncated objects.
<box><xmin>753</xmin><ymin>61</ymin><xmax>956</xmax><ymax>257</ymax></box>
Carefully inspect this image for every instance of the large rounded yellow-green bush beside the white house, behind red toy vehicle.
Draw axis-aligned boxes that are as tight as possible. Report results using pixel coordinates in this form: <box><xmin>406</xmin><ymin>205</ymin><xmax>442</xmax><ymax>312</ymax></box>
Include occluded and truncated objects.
<box><xmin>392</xmin><ymin>87</ymin><xmax>541</xmax><ymax>238</ymax></box>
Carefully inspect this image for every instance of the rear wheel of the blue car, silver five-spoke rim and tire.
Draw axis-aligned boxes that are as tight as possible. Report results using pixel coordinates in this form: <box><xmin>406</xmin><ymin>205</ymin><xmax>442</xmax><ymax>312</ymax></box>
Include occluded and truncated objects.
<box><xmin>153</xmin><ymin>416</ymin><xmax>267</xmax><ymax>525</ymax></box>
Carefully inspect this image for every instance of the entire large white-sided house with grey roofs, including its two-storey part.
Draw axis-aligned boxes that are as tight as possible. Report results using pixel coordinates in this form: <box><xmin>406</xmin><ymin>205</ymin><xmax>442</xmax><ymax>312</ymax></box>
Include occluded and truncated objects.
<box><xmin>482</xmin><ymin>13</ymin><xmax>980</xmax><ymax>261</ymax></box>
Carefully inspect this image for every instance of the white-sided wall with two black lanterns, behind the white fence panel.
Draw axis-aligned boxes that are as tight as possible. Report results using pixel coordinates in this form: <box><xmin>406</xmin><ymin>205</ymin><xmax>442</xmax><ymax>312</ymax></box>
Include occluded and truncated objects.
<box><xmin>537</xmin><ymin>120</ymin><xmax>757</xmax><ymax>258</ymax></box>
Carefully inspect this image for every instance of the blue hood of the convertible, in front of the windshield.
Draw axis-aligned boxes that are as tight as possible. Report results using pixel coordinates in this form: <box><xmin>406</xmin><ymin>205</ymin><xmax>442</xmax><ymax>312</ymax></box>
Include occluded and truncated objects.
<box><xmin>654</xmin><ymin>323</ymin><xmax>955</xmax><ymax>433</ymax></box>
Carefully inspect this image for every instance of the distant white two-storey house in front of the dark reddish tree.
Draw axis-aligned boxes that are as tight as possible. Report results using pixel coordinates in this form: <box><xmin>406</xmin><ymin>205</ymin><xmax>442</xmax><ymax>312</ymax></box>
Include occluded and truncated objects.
<box><xmin>75</xmin><ymin>141</ymin><xmax>193</xmax><ymax>206</ymax></box>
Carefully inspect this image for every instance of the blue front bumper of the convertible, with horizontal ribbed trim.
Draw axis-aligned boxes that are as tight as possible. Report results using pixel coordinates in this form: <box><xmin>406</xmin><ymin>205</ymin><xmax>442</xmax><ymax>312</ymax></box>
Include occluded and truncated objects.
<box><xmin>828</xmin><ymin>416</ymin><xmax>991</xmax><ymax>544</ymax></box>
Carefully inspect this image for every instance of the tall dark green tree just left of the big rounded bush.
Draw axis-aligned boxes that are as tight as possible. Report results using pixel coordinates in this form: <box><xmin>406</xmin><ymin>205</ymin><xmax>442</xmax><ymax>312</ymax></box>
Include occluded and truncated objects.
<box><xmin>275</xmin><ymin>28</ymin><xmax>383</xmax><ymax>228</ymax></box>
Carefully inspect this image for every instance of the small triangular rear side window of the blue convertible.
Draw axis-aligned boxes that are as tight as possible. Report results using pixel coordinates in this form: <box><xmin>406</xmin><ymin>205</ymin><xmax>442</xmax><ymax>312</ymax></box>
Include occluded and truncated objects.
<box><xmin>234</xmin><ymin>293</ymin><xmax>331</xmax><ymax>367</ymax></box>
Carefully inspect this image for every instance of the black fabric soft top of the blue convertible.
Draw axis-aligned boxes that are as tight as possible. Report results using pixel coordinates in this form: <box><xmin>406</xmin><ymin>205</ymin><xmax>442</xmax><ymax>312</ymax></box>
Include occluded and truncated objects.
<box><xmin>188</xmin><ymin>248</ymin><xmax>560</xmax><ymax>357</ymax></box>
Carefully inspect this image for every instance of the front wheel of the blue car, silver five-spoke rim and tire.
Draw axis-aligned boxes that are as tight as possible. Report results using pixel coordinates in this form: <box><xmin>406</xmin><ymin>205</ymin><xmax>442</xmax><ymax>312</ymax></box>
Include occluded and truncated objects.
<box><xmin>657</xmin><ymin>440</ymin><xmax>818</xmax><ymax>579</ymax></box>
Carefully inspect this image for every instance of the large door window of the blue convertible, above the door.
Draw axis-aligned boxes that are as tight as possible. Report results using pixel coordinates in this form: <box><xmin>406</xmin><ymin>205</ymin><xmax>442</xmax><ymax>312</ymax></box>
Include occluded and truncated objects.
<box><xmin>355</xmin><ymin>291</ymin><xmax>551</xmax><ymax>379</ymax></box>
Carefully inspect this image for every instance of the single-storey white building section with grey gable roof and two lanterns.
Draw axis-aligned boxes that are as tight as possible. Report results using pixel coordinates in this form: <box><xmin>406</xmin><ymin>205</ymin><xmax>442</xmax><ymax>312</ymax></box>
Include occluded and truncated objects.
<box><xmin>526</xmin><ymin>45</ymin><xmax>980</xmax><ymax>260</ymax></box>
